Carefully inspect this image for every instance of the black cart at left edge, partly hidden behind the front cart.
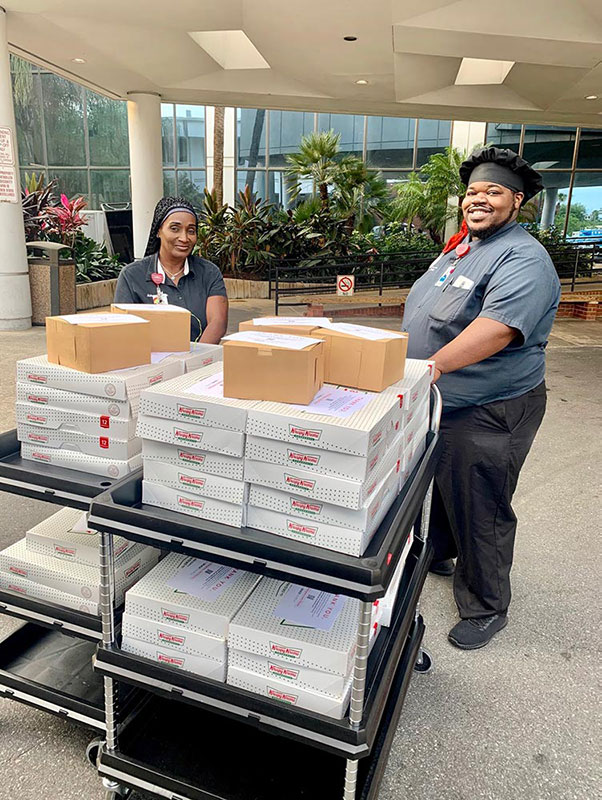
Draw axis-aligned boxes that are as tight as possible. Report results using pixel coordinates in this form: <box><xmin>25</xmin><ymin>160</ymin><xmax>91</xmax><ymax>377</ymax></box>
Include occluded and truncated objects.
<box><xmin>0</xmin><ymin>431</ymin><xmax>135</xmax><ymax>733</ymax></box>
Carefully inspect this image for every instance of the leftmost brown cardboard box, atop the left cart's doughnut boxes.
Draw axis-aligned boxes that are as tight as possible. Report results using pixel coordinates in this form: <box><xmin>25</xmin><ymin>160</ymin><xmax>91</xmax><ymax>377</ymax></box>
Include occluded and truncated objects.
<box><xmin>46</xmin><ymin>314</ymin><xmax>151</xmax><ymax>372</ymax></box>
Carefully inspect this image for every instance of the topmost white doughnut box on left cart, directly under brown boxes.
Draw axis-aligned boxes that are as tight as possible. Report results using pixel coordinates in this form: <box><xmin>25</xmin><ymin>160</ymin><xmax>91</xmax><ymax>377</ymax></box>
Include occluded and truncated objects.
<box><xmin>17</xmin><ymin>356</ymin><xmax>182</xmax><ymax>402</ymax></box>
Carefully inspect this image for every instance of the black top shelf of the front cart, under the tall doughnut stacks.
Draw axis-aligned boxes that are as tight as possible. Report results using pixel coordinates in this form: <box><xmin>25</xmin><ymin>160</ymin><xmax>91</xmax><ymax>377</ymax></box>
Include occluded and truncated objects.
<box><xmin>89</xmin><ymin>433</ymin><xmax>442</xmax><ymax>602</ymax></box>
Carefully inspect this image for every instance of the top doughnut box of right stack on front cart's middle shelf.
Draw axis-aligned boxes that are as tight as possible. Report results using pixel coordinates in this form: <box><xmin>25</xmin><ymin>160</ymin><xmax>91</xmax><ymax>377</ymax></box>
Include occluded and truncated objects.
<box><xmin>228</xmin><ymin>578</ymin><xmax>360</xmax><ymax>676</ymax></box>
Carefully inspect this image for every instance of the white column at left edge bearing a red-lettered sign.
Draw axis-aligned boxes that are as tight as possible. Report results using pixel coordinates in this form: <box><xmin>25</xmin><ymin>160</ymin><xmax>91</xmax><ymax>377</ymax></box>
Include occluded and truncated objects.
<box><xmin>0</xmin><ymin>7</ymin><xmax>31</xmax><ymax>331</ymax></box>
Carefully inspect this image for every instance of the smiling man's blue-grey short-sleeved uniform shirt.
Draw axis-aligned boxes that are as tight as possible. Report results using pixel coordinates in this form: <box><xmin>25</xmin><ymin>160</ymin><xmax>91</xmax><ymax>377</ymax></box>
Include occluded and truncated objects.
<box><xmin>402</xmin><ymin>222</ymin><xmax>560</xmax><ymax>411</ymax></box>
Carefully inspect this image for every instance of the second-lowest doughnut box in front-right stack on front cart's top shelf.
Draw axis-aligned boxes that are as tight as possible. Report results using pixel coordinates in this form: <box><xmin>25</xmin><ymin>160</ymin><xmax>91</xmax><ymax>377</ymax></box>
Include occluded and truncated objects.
<box><xmin>248</xmin><ymin>460</ymin><xmax>400</xmax><ymax>542</ymax></box>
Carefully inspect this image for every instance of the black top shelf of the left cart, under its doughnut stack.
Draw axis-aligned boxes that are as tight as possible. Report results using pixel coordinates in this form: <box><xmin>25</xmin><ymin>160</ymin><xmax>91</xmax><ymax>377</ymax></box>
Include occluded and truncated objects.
<box><xmin>0</xmin><ymin>430</ymin><xmax>134</xmax><ymax>511</ymax></box>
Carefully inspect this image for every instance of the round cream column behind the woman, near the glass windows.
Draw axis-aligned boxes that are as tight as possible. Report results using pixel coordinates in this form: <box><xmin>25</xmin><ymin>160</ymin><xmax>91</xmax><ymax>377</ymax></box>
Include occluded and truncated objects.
<box><xmin>127</xmin><ymin>92</ymin><xmax>163</xmax><ymax>258</ymax></box>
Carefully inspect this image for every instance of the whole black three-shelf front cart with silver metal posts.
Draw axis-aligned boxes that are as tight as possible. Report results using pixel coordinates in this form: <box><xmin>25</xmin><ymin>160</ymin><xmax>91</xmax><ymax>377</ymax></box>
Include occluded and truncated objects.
<box><xmin>89</xmin><ymin>389</ymin><xmax>442</xmax><ymax>800</ymax></box>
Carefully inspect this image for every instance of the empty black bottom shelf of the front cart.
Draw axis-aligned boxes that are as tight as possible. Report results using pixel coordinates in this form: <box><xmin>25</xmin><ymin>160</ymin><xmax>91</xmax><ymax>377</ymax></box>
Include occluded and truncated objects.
<box><xmin>99</xmin><ymin>617</ymin><xmax>424</xmax><ymax>800</ymax></box>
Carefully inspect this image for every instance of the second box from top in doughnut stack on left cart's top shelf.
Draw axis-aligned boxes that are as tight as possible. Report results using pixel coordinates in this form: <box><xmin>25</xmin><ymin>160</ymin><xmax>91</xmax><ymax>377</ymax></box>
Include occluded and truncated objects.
<box><xmin>17</xmin><ymin>383</ymin><xmax>140</xmax><ymax>420</ymax></box>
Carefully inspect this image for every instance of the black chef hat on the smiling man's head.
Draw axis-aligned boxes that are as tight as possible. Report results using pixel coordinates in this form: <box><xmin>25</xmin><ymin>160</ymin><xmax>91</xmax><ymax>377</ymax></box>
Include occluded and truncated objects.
<box><xmin>460</xmin><ymin>145</ymin><xmax>543</xmax><ymax>206</ymax></box>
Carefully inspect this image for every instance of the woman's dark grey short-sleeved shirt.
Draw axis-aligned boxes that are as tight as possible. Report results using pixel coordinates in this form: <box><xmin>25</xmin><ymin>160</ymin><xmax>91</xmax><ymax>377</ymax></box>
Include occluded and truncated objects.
<box><xmin>115</xmin><ymin>254</ymin><xmax>227</xmax><ymax>341</ymax></box>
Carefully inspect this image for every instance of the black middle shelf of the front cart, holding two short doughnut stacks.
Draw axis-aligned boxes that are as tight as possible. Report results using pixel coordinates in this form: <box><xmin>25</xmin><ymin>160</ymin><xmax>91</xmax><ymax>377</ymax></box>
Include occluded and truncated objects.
<box><xmin>96</xmin><ymin>540</ymin><xmax>432</xmax><ymax>759</ymax></box>
